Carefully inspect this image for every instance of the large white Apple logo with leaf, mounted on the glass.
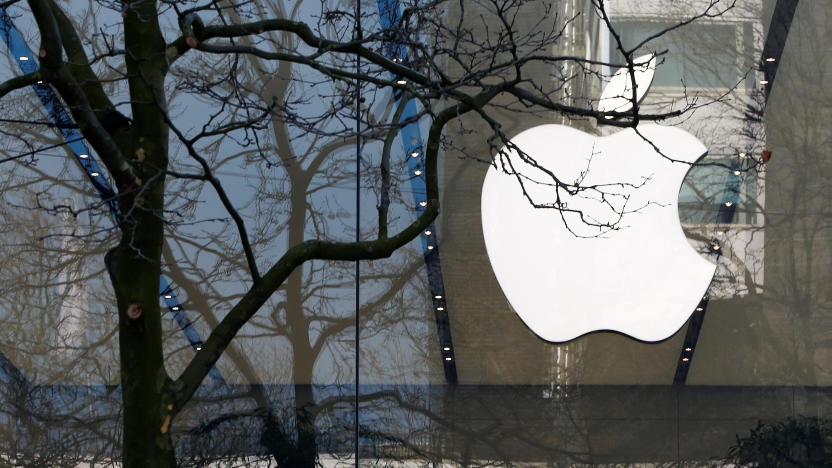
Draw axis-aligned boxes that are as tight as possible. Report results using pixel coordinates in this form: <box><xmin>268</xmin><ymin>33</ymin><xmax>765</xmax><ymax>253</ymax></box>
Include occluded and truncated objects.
<box><xmin>481</xmin><ymin>56</ymin><xmax>716</xmax><ymax>342</ymax></box>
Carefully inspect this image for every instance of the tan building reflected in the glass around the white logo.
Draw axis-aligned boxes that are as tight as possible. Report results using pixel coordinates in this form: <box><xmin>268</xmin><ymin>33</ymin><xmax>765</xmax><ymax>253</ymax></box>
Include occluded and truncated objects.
<box><xmin>441</xmin><ymin>1</ymin><xmax>832</xmax><ymax>466</ymax></box>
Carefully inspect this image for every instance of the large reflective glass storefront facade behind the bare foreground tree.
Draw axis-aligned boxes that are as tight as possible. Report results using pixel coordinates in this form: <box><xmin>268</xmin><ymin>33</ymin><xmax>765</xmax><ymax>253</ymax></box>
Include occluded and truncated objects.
<box><xmin>0</xmin><ymin>0</ymin><xmax>832</xmax><ymax>467</ymax></box>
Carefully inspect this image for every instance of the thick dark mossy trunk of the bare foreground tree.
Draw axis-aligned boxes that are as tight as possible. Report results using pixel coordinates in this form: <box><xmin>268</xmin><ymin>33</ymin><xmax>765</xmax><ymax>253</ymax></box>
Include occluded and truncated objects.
<box><xmin>110</xmin><ymin>0</ymin><xmax>178</xmax><ymax>462</ymax></box>
